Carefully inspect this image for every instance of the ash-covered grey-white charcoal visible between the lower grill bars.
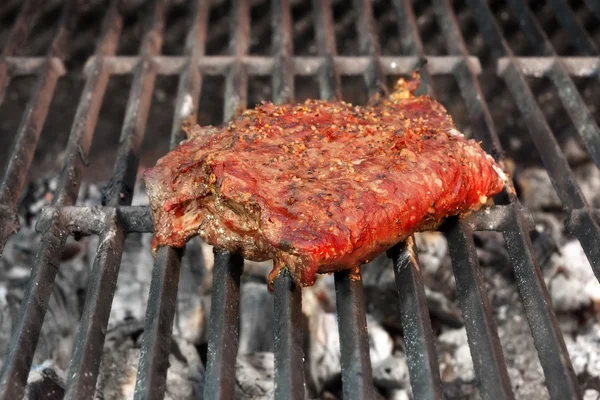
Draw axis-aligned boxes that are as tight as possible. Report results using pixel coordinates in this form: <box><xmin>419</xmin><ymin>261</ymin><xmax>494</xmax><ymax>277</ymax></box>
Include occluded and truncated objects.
<box><xmin>7</xmin><ymin>174</ymin><xmax>600</xmax><ymax>399</ymax></box>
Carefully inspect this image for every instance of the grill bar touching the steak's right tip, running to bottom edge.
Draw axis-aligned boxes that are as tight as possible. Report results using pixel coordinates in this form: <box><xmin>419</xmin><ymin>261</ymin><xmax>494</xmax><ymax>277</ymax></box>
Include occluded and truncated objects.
<box><xmin>434</xmin><ymin>0</ymin><xmax>580</xmax><ymax>398</ymax></box>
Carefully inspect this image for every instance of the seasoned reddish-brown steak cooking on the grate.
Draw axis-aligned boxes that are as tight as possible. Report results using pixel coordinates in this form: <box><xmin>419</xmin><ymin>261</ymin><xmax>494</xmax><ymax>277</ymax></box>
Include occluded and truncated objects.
<box><xmin>144</xmin><ymin>75</ymin><xmax>506</xmax><ymax>285</ymax></box>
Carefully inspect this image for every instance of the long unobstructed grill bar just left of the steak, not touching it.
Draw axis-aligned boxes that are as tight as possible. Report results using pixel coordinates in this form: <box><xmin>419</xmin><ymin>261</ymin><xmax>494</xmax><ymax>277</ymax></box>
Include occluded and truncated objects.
<box><xmin>66</xmin><ymin>2</ymin><xmax>164</xmax><ymax>399</ymax></box>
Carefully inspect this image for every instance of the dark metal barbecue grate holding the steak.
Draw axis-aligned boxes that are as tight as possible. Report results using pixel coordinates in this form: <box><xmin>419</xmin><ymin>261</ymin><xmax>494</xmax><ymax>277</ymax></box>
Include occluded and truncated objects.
<box><xmin>0</xmin><ymin>0</ymin><xmax>600</xmax><ymax>399</ymax></box>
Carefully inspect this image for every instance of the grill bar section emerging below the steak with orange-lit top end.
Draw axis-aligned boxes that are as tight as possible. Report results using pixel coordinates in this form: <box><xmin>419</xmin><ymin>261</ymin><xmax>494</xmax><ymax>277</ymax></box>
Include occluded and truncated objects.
<box><xmin>388</xmin><ymin>237</ymin><xmax>444</xmax><ymax>399</ymax></box>
